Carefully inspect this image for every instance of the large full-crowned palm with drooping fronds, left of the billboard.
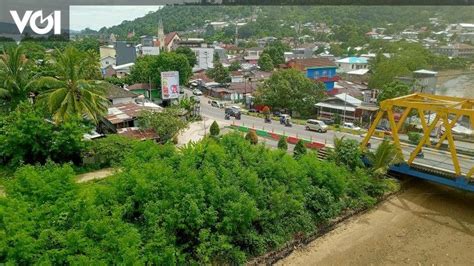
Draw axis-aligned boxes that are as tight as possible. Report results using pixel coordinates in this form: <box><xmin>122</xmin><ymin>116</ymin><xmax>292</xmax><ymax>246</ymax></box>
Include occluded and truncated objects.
<box><xmin>38</xmin><ymin>47</ymin><xmax>109</xmax><ymax>123</ymax></box>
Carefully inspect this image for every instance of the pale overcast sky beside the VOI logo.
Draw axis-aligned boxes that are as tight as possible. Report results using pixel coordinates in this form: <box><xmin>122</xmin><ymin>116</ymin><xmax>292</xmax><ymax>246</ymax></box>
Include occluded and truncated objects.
<box><xmin>69</xmin><ymin>6</ymin><xmax>161</xmax><ymax>30</ymax></box>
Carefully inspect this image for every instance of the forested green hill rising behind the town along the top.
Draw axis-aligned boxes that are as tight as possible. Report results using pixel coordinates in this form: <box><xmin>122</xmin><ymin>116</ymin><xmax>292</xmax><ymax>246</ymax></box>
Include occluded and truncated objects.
<box><xmin>95</xmin><ymin>6</ymin><xmax>474</xmax><ymax>38</ymax></box>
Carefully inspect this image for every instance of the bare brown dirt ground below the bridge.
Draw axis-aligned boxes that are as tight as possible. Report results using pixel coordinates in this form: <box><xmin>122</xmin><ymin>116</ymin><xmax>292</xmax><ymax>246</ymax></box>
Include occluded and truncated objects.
<box><xmin>277</xmin><ymin>180</ymin><xmax>474</xmax><ymax>265</ymax></box>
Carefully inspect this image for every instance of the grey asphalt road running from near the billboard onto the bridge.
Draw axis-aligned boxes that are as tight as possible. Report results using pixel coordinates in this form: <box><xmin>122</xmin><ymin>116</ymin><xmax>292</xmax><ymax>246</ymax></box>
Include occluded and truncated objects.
<box><xmin>186</xmin><ymin>91</ymin><xmax>474</xmax><ymax>177</ymax></box>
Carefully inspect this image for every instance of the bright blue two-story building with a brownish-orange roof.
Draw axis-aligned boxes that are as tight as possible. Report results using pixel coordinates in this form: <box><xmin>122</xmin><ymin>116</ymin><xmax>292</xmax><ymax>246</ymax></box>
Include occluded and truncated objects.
<box><xmin>286</xmin><ymin>58</ymin><xmax>339</xmax><ymax>91</ymax></box>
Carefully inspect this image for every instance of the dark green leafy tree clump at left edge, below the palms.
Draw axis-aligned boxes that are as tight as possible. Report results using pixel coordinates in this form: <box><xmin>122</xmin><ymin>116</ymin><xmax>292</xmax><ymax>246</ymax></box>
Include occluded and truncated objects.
<box><xmin>0</xmin><ymin>103</ymin><xmax>87</xmax><ymax>167</ymax></box>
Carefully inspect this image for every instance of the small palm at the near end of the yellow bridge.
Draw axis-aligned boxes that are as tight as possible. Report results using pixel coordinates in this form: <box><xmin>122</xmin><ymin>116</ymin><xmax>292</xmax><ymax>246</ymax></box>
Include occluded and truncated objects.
<box><xmin>366</xmin><ymin>139</ymin><xmax>403</xmax><ymax>177</ymax></box>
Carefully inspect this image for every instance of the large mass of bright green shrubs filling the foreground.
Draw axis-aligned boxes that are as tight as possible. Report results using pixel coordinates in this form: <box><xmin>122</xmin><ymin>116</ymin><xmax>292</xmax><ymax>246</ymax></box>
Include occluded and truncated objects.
<box><xmin>0</xmin><ymin>135</ymin><xmax>396</xmax><ymax>265</ymax></box>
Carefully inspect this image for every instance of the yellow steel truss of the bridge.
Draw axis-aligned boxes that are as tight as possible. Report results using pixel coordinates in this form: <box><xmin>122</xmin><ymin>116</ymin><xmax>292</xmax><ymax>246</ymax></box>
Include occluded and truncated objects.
<box><xmin>361</xmin><ymin>93</ymin><xmax>474</xmax><ymax>177</ymax></box>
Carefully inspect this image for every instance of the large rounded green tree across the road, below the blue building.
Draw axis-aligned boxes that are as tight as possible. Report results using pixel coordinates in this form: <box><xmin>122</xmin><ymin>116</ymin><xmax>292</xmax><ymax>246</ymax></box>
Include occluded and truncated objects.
<box><xmin>256</xmin><ymin>69</ymin><xmax>326</xmax><ymax>116</ymax></box>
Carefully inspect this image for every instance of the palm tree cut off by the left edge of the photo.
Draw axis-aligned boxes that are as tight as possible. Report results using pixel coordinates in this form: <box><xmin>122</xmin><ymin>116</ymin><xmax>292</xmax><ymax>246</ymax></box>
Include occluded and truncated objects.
<box><xmin>0</xmin><ymin>46</ymin><xmax>33</xmax><ymax>110</ymax></box>
